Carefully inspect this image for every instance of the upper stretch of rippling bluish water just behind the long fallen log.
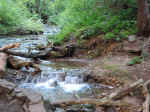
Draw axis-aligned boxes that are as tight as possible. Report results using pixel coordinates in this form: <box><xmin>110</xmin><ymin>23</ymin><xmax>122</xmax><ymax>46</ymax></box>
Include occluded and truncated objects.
<box><xmin>0</xmin><ymin>35</ymin><xmax>48</xmax><ymax>54</ymax></box>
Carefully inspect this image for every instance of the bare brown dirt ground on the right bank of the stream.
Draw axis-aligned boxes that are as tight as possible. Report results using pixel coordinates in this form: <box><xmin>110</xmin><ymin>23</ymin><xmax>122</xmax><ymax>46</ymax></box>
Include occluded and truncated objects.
<box><xmin>68</xmin><ymin>34</ymin><xmax>150</xmax><ymax>112</ymax></box>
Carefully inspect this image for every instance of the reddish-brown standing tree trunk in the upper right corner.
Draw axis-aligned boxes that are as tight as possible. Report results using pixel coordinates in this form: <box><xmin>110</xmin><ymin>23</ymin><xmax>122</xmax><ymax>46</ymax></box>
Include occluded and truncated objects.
<box><xmin>138</xmin><ymin>0</ymin><xmax>150</xmax><ymax>36</ymax></box>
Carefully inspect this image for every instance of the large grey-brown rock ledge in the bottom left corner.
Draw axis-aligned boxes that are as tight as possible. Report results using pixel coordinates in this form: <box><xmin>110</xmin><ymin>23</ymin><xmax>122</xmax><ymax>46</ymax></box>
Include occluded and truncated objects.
<box><xmin>0</xmin><ymin>79</ymin><xmax>46</xmax><ymax>112</ymax></box>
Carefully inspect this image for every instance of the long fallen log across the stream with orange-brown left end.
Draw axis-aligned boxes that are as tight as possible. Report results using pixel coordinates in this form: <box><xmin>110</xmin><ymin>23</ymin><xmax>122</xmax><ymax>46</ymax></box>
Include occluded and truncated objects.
<box><xmin>0</xmin><ymin>43</ymin><xmax>75</xmax><ymax>58</ymax></box>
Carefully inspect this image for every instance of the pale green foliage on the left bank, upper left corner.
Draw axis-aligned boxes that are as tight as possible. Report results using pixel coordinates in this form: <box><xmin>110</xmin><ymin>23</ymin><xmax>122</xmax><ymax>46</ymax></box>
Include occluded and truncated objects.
<box><xmin>0</xmin><ymin>0</ymin><xmax>42</xmax><ymax>34</ymax></box>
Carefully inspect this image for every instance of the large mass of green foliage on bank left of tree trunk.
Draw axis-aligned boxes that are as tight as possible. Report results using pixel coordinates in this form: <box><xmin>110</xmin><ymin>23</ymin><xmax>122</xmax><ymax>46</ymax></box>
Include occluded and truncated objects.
<box><xmin>49</xmin><ymin>0</ymin><xmax>137</xmax><ymax>41</ymax></box>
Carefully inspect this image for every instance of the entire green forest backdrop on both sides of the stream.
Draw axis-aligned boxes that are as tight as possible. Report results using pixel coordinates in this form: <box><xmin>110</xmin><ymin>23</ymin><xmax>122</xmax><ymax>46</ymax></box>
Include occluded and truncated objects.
<box><xmin>0</xmin><ymin>0</ymin><xmax>145</xmax><ymax>43</ymax></box>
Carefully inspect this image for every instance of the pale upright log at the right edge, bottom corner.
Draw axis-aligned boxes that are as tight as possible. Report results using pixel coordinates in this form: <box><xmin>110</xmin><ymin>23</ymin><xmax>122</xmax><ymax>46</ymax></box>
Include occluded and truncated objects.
<box><xmin>143</xmin><ymin>80</ymin><xmax>150</xmax><ymax>112</ymax></box>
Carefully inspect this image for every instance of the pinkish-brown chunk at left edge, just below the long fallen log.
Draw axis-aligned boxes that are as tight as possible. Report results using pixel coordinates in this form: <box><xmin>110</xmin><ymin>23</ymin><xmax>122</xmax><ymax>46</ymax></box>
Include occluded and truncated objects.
<box><xmin>0</xmin><ymin>53</ymin><xmax>8</xmax><ymax>76</ymax></box>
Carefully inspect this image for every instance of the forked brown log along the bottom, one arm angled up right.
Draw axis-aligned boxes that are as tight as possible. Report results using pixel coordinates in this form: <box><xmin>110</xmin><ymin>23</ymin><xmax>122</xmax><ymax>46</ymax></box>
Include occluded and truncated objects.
<box><xmin>51</xmin><ymin>79</ymin><xmax>143</xmax><ymax>107</ymax></box>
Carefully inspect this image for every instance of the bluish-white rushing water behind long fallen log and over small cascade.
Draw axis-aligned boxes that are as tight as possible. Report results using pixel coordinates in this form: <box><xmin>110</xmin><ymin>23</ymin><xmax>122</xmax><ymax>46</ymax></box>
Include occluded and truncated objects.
<box><xmin>0</xmin><ymin>26</ymin><xmax>112</xmax><ymax>111</ymax></box>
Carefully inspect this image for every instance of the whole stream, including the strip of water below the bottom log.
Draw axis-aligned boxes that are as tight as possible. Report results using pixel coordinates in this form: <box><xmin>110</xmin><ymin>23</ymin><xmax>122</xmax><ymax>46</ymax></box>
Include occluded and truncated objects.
<box><xmin>0</xmin><ymin>25</ymin><xmax>111</xmax><ymax>112</ymax></box>
